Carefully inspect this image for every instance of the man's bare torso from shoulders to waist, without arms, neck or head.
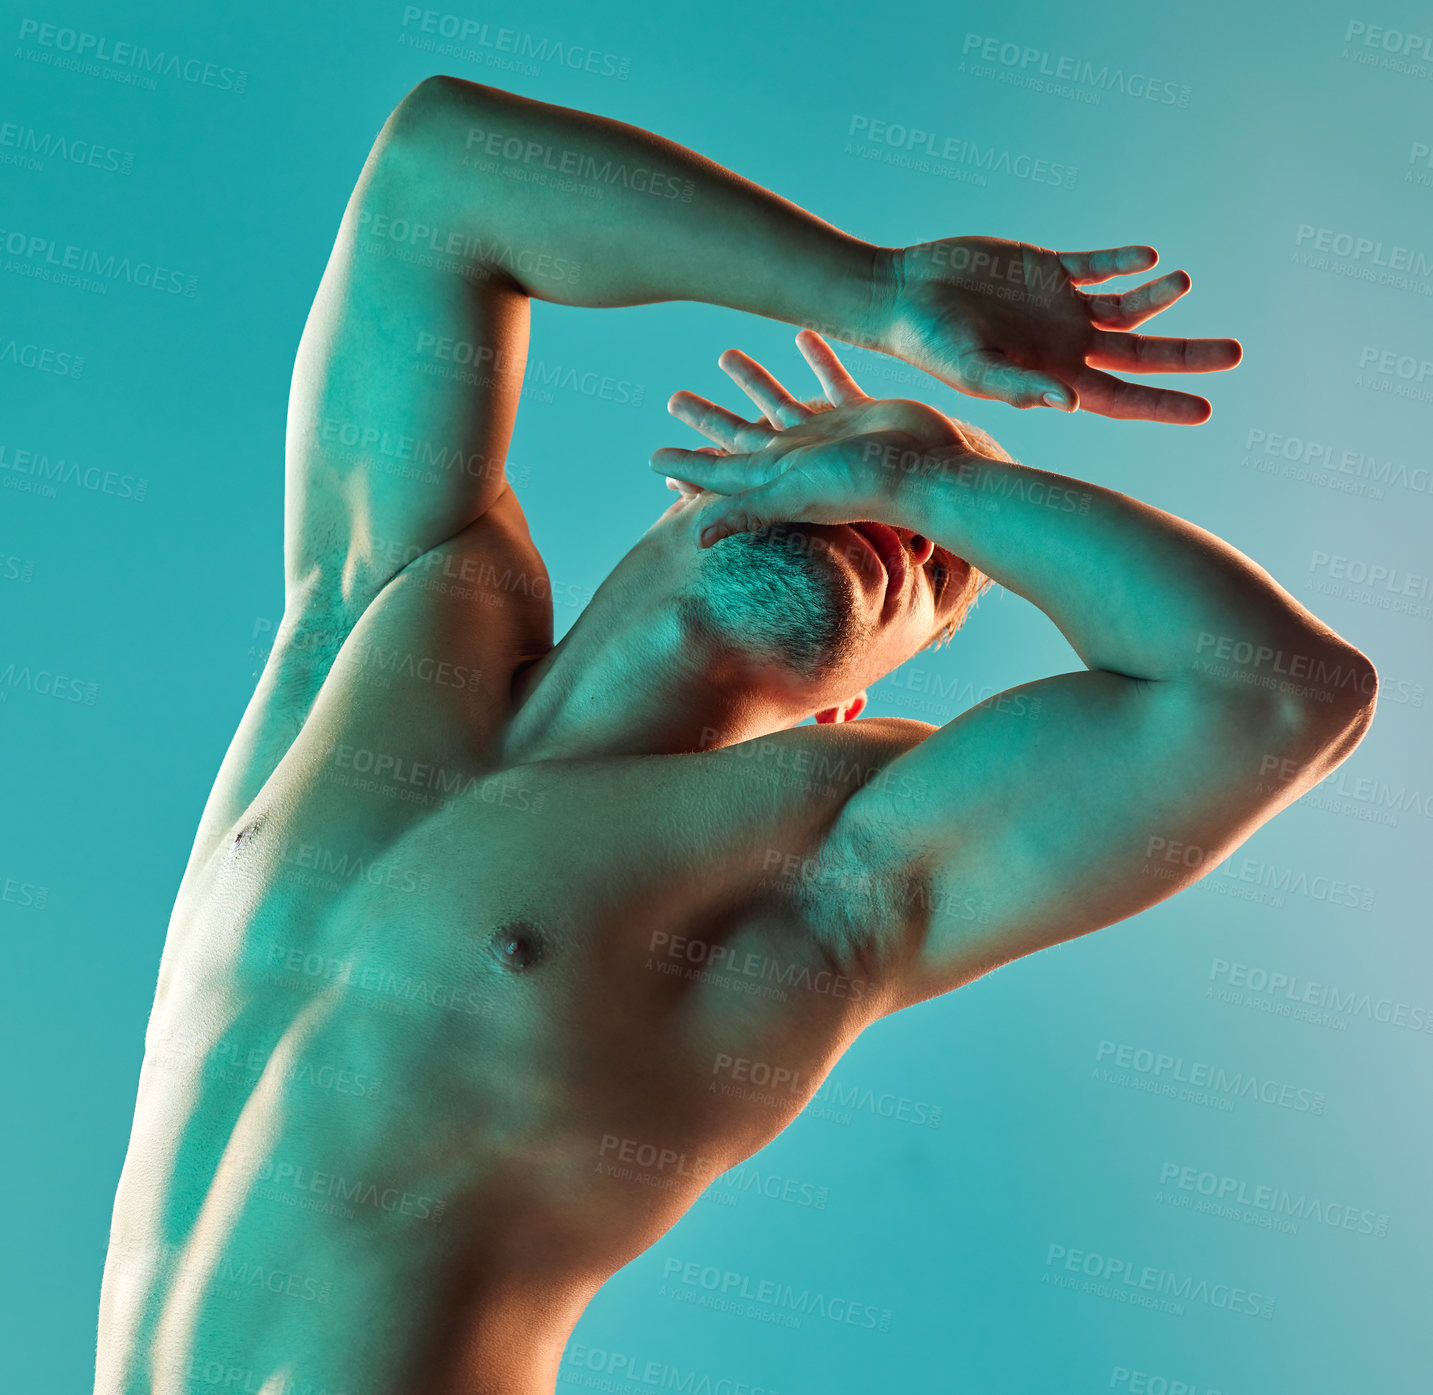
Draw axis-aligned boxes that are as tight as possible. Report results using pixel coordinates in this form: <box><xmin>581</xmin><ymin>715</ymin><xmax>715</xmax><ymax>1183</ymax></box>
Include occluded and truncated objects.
<box><xmin>97</xmin><ymin>493</ymin><xmax>929</xmax><ymax>1395</ymax></box>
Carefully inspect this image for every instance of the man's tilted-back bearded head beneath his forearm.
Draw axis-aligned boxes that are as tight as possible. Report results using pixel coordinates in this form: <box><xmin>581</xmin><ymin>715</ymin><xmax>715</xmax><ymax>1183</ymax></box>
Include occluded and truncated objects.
<box><xmin>558</xmin><ymin>401</ymin><xmax>1010</xmax><ymax>730</ymax></box>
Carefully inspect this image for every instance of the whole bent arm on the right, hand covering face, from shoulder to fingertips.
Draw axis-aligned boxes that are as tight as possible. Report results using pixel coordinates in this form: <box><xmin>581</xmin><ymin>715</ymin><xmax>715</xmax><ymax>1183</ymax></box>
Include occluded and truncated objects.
<box><xmin>655</xmin><ymin>343</ymin><xmax>1377</xmax><ymax>1006</ymax></box>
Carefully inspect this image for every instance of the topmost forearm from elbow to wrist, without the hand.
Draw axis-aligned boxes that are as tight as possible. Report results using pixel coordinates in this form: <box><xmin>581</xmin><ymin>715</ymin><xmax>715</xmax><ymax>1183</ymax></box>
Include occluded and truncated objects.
<box><xmin>394</xmin><ymin>77</ymin><xmax>888</xmax><ymax>341</ymax></box>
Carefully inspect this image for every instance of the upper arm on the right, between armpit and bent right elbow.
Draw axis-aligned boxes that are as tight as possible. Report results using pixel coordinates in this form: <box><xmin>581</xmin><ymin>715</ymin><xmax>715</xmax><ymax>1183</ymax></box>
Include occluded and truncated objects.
<box><xmin>842</xmin><ymin>671</ymin><xmax>1311</xmax><ymax>1001</ymax></box>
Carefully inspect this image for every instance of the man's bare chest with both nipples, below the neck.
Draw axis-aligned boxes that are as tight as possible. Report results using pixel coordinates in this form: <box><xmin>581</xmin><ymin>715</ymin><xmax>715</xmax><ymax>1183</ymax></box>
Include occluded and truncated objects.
<box><xmin>202</xmin><ymin>612</ymin><xmax>934</xmax><ymax>1038</ymax></box>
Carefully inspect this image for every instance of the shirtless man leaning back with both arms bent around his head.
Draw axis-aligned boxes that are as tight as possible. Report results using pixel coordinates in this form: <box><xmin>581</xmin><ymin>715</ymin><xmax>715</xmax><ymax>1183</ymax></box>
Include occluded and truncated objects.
<box><xmin>96</xmin><ymin>77</ymin><xmax>1376</xmax><ymax>1395</ymax></box>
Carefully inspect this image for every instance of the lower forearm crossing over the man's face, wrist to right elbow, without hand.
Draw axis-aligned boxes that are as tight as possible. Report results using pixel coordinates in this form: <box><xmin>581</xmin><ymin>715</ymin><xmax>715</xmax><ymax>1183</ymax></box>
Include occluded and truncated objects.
<box><xmin>890</xmin><ymin>452</ymin><xmax>1373</xmax><ymax>703</ymax></box>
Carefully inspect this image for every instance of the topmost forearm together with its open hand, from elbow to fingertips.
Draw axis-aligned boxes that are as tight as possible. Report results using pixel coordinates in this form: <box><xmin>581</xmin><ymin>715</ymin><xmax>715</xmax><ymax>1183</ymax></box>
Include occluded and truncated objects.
<box><xmin>406</xmin><ymin>77</ymin><xmax>1241</xmax><ymax>423</ymax></box>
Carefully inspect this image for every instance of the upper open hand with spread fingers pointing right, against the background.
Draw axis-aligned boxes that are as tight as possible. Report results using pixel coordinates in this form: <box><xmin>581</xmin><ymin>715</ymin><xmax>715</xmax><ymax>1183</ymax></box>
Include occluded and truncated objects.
<box><xmin>878</xmin><ymin>238</ymin><xmax>1244</xmax><ymax>426</ymax></box>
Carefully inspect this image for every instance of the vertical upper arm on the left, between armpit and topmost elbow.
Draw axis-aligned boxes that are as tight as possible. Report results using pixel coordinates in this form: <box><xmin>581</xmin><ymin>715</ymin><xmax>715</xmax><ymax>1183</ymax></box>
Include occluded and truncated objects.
<box><xmin>285</xmin><ymin>113</ymin><xmax>527</xmax><ymax>618</ymax></box>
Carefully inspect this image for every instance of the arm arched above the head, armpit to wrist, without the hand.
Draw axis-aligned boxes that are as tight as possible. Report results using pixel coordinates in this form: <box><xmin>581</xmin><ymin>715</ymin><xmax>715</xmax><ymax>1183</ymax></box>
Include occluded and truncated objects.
<box><xmin>287</xmin><ymin>77</ymin><xmax>880</xmax><ymax>634</ymax></box>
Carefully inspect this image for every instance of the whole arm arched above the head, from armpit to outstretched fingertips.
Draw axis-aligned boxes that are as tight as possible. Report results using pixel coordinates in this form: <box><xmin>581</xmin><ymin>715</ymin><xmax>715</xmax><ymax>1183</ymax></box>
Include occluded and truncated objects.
<box><xmin>285</xmin><ymin>77</ymin><xmax>1238</xmax><ymax>631</ymax></box>
